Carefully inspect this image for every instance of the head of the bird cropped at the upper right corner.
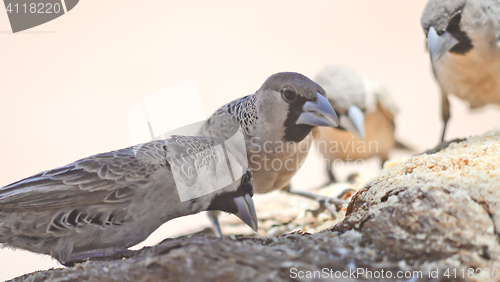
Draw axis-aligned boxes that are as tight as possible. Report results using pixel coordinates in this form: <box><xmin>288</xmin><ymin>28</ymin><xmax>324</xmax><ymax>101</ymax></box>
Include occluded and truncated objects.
<box><xmin>421</xmin><ymin>0</ymin><xmax>472</xmax><ymax>63</ymax></box>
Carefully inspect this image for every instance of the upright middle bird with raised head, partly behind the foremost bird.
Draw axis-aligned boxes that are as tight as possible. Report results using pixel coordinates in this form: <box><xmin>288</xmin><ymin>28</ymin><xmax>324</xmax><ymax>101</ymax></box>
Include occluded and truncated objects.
<box><xmin>197</xmin><ymin>72</ymin><xmax>346</xmax><ymax>237</ymax></box>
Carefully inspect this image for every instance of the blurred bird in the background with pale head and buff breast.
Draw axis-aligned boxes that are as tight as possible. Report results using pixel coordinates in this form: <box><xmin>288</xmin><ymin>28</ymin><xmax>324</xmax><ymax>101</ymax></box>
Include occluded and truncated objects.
<box><xmin>315</xmin><ymin>66</ymin><xmax>407</xmax><ymax>182</ymax></box>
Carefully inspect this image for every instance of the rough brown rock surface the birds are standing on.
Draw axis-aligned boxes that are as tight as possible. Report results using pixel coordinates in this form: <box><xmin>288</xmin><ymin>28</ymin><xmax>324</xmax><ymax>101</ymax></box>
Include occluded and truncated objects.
<box><xmin>8</xmin><ymin>128</ymin><xmax>500</xmax><ymax>281</ymax></box>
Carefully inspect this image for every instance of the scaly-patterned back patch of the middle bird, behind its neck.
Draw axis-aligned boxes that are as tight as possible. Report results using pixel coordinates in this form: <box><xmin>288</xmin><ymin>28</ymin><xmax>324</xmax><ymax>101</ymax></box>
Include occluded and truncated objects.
<box><xmin>197</xmin><ymin>94</ymin><xmax>257</xmax><ymax>139</ymax></box>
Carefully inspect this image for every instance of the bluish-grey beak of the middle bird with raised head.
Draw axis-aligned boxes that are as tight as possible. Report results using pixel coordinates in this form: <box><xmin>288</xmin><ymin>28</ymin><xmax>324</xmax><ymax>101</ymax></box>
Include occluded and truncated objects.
<box><xmin>296</xmin><ymin>93</ymin><xmax>339</xmax><ymax>127</ymax></box>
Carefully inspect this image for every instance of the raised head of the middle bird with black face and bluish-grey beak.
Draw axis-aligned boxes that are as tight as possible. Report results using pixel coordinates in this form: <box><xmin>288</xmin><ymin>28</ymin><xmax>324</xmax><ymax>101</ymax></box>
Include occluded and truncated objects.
<box><xmin>255</xmin><ymin>72</ymin><xmax>339</xmax><ymax>142</ymax></box>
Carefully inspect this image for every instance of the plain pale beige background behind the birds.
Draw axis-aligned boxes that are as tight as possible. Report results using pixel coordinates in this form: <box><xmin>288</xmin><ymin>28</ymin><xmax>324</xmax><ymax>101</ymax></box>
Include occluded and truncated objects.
<box><xmin>0</xmin><ymin>0</ymin><xmax>500</xmax><ymax>279</ymax></box>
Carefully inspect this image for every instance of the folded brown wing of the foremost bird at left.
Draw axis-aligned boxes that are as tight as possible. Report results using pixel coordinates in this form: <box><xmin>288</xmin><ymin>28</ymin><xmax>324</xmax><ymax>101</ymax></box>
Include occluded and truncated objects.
<box><xmin>0</xmin><ymin>140</ymin><xmax>170</xmax><ymax>211</ymax></box>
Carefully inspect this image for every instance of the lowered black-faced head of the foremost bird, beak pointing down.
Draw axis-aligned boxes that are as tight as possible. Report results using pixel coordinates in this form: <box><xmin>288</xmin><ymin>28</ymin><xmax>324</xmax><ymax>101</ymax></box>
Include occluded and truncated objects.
<box><xmin>207</xmin><ymin>170</ymin><xmax>258</xmax><ymax>231</ymax></box>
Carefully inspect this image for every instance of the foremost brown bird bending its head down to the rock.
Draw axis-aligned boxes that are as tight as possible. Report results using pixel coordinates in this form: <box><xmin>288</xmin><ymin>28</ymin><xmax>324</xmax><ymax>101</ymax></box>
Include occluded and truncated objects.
<box><xmin>0</xmin><ymin>136</ymin><xmax>257</xmax><ymax>265</ymax></box>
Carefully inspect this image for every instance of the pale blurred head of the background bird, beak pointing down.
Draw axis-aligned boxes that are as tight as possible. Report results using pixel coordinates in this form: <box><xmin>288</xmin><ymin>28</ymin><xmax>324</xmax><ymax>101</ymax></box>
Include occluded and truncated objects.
<box><xmin>315</xmin><ymin>66</ymin><xmax>369</xmax><ymax>140</ymax></box>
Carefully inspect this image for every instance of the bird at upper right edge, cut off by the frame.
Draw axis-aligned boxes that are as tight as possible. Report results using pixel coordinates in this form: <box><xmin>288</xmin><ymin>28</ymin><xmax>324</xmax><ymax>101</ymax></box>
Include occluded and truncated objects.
<box><xmin>421</xmin><ymin>0</ymin><xmax>500</xmax><ymax>141</ymax></box>
